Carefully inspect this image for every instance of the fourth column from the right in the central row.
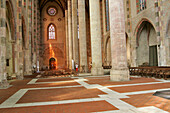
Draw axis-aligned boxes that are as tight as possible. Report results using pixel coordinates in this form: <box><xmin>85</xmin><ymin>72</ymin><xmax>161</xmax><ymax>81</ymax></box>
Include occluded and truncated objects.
<box><xmin>72</xmin><ymin>0</ymin><xmax>79</xmax><ymax>63</ymax></box>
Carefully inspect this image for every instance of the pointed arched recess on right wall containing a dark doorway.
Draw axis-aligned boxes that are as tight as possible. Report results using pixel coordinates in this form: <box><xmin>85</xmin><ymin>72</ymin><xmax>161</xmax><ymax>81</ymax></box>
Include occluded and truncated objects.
<box><xmin>136</xmin><ymin>21</ymin><xmax>158</xmax><ymax>66</ymax></box>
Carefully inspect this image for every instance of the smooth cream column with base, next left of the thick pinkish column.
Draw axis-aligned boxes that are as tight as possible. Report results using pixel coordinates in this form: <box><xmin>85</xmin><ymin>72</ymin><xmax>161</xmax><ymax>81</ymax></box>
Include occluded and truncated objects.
<box><xmin>89</xmin><ymin>0</ymin><xmax>104</xmax><ymax>75</ymax></box>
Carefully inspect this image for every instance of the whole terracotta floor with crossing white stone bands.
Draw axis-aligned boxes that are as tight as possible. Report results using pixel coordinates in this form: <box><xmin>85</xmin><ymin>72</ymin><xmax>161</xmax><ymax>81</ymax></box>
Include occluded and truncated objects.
<box><xmin>0</xmin><ymin>76</ymin><xmax>170</xmax><ymax>113</ymax></box>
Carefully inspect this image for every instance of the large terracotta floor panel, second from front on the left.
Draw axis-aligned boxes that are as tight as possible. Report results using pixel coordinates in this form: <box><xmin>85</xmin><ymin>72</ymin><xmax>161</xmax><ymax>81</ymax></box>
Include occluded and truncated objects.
<box><xmin>18</xmin><ymin>87</ymin><xmax>105</xmax><ymax>103</ymax></box>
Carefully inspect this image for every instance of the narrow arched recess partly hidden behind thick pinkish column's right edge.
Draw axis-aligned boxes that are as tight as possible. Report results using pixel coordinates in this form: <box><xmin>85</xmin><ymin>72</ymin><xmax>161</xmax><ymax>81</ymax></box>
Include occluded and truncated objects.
<box><xmin>126</xmin><ymin>33</ymin><xmax>131</xmax><ymax>66</ymax></box>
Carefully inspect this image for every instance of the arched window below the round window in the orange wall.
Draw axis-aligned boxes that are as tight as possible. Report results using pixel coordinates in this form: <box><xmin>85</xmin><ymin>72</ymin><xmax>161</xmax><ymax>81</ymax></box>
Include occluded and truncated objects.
<box><xmin>48</xmin><ymin>24</ymin><xmax>56</xmax><ymax>40</ymax></box>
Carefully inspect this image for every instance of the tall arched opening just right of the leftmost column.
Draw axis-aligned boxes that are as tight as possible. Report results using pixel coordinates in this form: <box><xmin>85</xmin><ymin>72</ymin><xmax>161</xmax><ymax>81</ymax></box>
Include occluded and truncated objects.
<box><xmin>6</xmin><ymin>0</ymin><xmax>16</xmax><ymax>77</ymax></box>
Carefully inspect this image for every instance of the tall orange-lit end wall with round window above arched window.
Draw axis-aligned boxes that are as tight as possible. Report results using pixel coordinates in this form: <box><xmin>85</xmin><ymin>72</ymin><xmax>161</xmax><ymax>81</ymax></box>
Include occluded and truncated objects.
<box><xmin>39</xmin><ymin>0</ymin><xmax>67</xmax><ymax>69</ymax></box>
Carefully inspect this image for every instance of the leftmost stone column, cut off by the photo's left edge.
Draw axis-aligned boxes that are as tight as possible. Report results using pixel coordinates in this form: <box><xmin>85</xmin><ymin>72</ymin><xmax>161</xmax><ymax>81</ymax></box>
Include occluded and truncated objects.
<box><xmin>0</xmin><ymin>0</ymin><xmax>9</xmax><ymax>88</ymax></box>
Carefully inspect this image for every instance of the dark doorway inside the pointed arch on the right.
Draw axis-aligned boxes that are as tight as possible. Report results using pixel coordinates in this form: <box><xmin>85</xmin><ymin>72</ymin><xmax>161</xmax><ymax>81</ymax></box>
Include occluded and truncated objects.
<box><xmin>149</xmin><ymin>45</ymin><xmax>158</xmax><ymax>66</ymax></box>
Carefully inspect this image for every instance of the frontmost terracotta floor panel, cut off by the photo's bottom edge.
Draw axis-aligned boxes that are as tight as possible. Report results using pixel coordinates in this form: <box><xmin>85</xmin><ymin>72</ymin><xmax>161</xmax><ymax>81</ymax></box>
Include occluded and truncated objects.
<box><xmin>0</xmin><ymin>101</ymin><xmax>118</xmax><ymax>113</ymax></box>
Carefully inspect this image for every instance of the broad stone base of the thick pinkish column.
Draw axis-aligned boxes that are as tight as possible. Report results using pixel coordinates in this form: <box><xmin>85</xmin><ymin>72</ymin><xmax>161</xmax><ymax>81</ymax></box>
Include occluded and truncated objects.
<box><xmin>110</xmin><ymin>69</ymin><xmax>130</xmax><ymax>81</ymax></box>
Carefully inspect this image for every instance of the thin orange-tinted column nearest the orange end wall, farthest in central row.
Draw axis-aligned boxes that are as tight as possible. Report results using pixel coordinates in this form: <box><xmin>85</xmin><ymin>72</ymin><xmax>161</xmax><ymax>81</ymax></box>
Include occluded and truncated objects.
<box><xmin>65</xmin><ymin>10</ymin><xmax>69</xmax><ymax>68</ymax></box>
